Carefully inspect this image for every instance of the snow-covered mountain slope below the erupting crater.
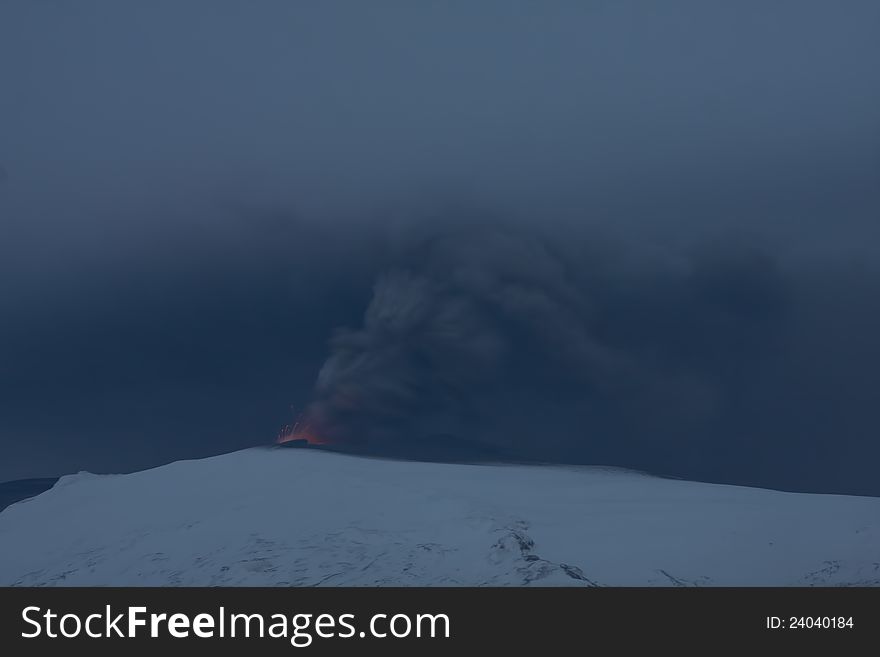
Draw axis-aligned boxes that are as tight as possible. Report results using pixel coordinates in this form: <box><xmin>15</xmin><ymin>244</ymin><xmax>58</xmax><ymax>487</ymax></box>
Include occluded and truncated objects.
<box><xmin>0</xmin><ymin>449</ymin><xmax>880</xmax><ymax>586</ymax></box>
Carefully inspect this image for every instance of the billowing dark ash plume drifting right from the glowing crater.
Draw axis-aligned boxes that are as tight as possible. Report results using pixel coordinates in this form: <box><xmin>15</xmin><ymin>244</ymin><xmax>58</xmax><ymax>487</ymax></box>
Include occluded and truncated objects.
<box><xmin>300</xmin><ymin>223</ymin><xmax>792</xmax><ymax>472</ymax></box>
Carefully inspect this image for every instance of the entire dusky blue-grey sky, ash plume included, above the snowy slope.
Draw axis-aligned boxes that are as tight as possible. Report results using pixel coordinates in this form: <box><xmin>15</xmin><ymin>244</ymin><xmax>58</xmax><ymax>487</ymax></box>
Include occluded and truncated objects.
<box><xmin>0</xmin><ymin>0</ymin><xmax>880</xmax><ymax>494</ymax></box>
